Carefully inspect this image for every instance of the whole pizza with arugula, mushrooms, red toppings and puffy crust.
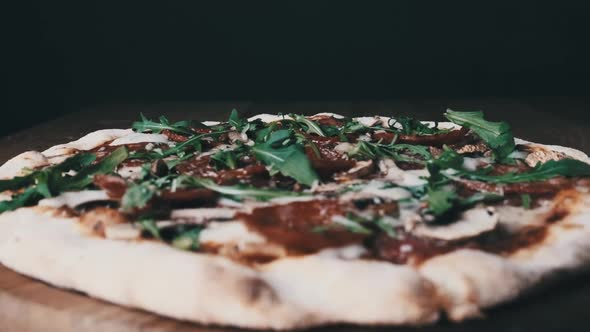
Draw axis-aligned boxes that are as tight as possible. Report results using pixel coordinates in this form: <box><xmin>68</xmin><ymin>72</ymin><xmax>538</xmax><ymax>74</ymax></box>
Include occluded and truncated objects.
<box><xmin>0</xmin><ymin>110</ymin><xmax>590</xmax><ymax>329</ymax></box>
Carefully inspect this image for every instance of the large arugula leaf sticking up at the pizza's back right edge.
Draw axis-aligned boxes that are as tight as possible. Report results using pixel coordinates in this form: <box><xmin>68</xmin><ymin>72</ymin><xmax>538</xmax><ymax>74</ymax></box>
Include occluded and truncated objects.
<box><xmin>444</xmin><ymin>109</ymin><xmax>515</xmax><ymax>161</ymax></box>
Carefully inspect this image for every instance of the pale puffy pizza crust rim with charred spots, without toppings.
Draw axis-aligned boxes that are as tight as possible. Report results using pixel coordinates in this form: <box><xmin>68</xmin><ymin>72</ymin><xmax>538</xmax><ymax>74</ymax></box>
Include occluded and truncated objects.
<box><xmin>0</xmin><ymin>115</ymin><xmax>590</xmax><ymax>329</ymax></box>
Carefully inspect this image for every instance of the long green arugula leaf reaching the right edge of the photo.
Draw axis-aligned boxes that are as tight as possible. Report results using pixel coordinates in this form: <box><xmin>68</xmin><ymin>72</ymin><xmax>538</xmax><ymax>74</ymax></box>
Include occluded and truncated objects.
<box><xmin>457</xmin><ymin>159</ymin><xmax>590</xmax><ymax>183</ymax></box>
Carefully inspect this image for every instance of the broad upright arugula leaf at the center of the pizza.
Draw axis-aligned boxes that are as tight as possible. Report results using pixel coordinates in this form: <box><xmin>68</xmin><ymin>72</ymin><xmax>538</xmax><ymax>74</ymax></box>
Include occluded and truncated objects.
<box><xmin>251</xmin><ymin>129</ymin><xmax>319</xmax><ymax>186</ymax></box>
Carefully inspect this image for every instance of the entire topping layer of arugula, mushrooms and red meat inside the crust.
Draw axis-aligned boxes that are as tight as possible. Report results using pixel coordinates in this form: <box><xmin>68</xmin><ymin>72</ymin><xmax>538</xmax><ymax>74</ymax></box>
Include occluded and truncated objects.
<box><xmin>0</xmin><ymin>110</ymin><xmax>590</xmax><ymax>263</ymax></box>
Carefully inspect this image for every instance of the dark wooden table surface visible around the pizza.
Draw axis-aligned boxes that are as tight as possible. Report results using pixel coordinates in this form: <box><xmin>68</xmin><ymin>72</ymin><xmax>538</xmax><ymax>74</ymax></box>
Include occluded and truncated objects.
<box><xmin>0</xmin><ymin>98</ymin><xmax>590</xmax><ymax>332</ymax></box>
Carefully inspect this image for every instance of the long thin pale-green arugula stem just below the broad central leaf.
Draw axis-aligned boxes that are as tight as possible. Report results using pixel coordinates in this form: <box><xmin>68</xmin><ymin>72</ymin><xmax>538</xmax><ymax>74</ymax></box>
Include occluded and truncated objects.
<box><xmin>188</xmin><ymin>177</ymin><xmax>304</xmax><ymax>200</ymax></box>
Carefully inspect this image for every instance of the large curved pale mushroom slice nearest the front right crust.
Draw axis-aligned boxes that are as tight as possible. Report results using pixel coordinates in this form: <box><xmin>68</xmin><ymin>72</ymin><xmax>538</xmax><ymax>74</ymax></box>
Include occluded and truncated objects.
<box><xmin>412</xmin><ymin>207</ymin><xmax>499</xmax><ymax>241</ymax></box>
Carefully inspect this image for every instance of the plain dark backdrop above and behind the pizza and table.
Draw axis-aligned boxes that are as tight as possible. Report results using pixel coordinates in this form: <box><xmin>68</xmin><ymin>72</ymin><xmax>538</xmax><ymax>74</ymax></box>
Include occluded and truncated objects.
<box><xmin>0</xmin><ymin>1</ymin><xmax>590</xmax><ymax>134</ymax></box>
